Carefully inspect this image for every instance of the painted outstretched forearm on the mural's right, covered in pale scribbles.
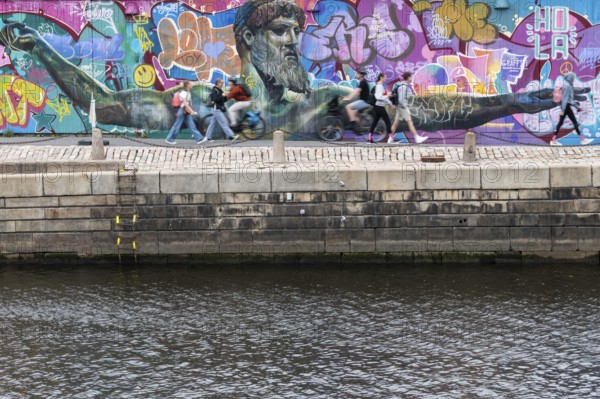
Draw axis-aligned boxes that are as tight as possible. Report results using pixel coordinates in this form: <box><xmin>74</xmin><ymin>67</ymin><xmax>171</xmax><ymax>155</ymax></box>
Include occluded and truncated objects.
<box><xmin>400</xmin><ymin>88</ymin><xmax>590</xmax><ymax>131</ymax></box>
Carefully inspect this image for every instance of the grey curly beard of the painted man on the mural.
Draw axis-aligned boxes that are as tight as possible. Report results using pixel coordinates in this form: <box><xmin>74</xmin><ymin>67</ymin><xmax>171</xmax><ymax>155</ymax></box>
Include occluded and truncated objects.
<box><xmin>250</xmin><ymin>35</ymin><xmax>309</xmax><ymax>93</ymax></box>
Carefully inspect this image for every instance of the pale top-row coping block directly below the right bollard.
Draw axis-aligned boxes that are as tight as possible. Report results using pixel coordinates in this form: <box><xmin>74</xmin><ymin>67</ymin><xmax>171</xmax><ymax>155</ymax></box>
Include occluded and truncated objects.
<box><xmin>416</xmin><ymin>162</ymin><xmax>481</xmax><ymax>190</ymax></box>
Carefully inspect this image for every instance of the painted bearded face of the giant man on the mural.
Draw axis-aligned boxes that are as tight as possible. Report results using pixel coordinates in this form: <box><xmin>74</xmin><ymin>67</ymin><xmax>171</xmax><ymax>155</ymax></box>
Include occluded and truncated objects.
<box><xmin>250</xmin><ymin>17</ymin><xmax>309</xmax><ymax>93</ymax></box>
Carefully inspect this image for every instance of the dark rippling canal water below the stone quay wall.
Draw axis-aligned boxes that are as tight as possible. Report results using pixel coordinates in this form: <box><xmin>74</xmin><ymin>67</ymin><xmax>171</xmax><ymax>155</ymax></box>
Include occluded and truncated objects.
<box><xmin>0</xmin><ymin>265</ymin><xmax>600</xmax><ymax>399</ymax></box>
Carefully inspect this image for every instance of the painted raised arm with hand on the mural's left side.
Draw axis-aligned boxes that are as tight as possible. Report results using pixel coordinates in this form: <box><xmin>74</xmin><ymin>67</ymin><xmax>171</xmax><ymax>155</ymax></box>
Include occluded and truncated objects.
<box><xmin>0</xmin><ymin>22</ymin><xmax>164</xmax><ymax>126</ymax></box>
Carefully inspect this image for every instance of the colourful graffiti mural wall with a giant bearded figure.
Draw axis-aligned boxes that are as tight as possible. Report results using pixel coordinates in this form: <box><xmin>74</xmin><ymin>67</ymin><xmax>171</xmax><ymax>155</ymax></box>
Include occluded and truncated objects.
<box><xmin>0</xmin><ymin>0</ymin><xmax>600</xmax><ymax>144</ymax></box>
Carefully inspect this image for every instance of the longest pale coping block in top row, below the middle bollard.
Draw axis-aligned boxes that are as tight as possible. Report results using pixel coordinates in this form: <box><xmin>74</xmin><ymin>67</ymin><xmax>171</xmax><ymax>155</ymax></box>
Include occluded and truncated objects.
<box><xmin>271</xmin><ymin>163</ymin><xmax>367</xmax><ymax>193</ymax></box>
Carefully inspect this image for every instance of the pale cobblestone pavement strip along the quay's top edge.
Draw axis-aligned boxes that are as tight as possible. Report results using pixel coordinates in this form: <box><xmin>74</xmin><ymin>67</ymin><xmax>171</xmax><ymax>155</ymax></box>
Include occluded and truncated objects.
<box><xmin>0</xmin><ymin>138</ymin><xmax>600</xmax><ymax>170</ymax></box>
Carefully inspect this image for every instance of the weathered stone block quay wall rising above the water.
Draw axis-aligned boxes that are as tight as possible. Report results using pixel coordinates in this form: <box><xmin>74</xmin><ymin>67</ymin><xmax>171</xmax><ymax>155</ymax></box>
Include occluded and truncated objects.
<box><xmin>0</xmin><ymin>160</ymin><xmax>600</xmax><ymax>264</ymax></box>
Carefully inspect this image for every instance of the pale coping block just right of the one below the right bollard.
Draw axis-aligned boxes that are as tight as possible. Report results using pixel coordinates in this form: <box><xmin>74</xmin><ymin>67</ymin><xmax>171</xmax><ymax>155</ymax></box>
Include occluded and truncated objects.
<box><xmin>481</xmin><ymin>161</ymin><xmax>550</xmax><ymax>190</ymax></box>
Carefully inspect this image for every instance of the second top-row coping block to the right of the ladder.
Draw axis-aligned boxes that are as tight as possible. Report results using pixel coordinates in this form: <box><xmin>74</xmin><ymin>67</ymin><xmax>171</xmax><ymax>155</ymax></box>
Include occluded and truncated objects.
<box><xmin>160</xmin><ymin>168</ymin><xmax>219</xmax><ymax>194</ymax></box>
